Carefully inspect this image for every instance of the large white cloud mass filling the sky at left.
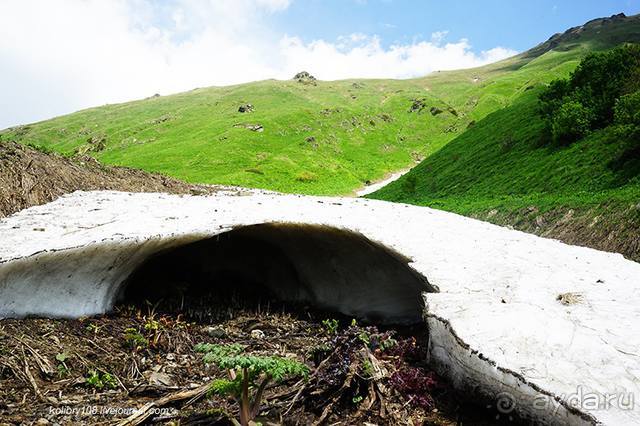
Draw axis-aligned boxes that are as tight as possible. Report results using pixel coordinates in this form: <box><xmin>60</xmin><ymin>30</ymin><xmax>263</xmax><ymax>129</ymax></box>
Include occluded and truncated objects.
<box><xmin>0</xmin><ymin>0</ymin><xmax>515</xmax><ymax>128</ymax></box>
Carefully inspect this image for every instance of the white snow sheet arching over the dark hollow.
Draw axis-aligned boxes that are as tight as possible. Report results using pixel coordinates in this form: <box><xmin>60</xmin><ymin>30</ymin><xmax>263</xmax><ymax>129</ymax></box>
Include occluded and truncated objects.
<box><xmin>0</xmin><ymin>191</ymin><xmax>640</xmax><ymax>426</ymax></box>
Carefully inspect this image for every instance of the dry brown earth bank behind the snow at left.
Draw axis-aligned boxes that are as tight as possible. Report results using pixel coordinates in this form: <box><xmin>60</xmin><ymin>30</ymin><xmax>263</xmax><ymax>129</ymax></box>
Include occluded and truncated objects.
<box><xmin>0</xmin><ymin>142</ymin><xmax>216</xmax><ymax>217</ymax></box>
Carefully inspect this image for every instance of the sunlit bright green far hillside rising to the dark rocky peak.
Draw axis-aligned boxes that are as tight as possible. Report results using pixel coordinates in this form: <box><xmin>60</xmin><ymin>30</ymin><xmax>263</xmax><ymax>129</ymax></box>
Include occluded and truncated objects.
<box><xmin>0</xmin><ymin>12</ymin><xmax>640</xmax><ymax>195</ymax></box>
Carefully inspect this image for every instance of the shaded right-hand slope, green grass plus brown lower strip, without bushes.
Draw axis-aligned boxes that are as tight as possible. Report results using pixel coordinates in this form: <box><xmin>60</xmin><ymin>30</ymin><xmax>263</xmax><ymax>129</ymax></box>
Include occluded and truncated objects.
<box><xmin>370</xmin><ymin>45</ymin><xmax>640</xmax><ymax>260</ymax></box>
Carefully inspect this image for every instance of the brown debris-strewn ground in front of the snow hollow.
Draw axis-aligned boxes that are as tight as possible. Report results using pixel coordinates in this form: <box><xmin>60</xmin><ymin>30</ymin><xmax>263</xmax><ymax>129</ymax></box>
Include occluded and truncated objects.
<box><xmin>0</xmin><ymin>294</ymin><xmax>515</xmax><ymax>425</ymax></box>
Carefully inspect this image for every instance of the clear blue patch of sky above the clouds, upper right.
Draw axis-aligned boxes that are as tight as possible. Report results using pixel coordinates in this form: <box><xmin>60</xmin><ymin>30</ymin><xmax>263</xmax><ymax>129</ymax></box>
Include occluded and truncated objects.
<box><xmin>273</xmin><ymin>0</ymin><xmax>640</xmax><ymax>51</ymax></box>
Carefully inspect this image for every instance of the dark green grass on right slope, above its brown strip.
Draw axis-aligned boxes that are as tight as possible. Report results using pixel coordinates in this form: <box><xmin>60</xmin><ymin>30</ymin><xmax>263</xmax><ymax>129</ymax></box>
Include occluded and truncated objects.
<box><xmin>372</xmin><ymin>90</ymin><xmax>640</xmax><ymax>214</ymax></box>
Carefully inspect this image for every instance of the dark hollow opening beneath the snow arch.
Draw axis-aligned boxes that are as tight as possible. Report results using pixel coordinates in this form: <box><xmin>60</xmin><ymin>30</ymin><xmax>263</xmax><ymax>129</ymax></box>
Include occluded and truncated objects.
<box><xmin>119</xmin><ymin>223</ymin><xmax>435</xmax><ymax>323</ymax></box>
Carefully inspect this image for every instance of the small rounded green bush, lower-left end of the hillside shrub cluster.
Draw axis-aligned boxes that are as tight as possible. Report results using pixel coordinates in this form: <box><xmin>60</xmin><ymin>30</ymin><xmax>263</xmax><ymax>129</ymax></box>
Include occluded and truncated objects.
<box><xmin>551</xmin><ymin>101</ymin><xmax>594</xmax><ymax>144</ymax></box>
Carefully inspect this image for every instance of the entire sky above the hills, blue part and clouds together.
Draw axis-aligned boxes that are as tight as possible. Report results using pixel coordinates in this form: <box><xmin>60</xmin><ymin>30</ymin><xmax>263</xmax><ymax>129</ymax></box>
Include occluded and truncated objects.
<box><xmin>0</xmin><ymin>0</ymin><xmax>640</xmax><ymax>128</ymax></box>
